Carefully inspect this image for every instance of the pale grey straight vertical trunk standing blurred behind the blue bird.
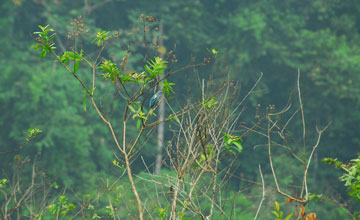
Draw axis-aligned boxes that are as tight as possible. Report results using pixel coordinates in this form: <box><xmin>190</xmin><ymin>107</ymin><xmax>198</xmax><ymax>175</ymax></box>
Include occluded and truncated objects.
<box><xmin>155</xmin><ymin>23</ymin><xmax>165</xmax><ymax>174</ymax></box>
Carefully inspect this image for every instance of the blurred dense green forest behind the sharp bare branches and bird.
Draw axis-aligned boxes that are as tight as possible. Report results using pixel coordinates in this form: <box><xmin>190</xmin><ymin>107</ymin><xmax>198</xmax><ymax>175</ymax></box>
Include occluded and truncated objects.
<box><xmin>0</xmin><ymin>0</ymin><xmax>360</xmax><ymax>219</ymax></box>
